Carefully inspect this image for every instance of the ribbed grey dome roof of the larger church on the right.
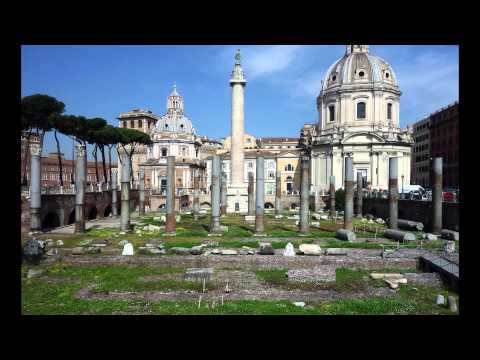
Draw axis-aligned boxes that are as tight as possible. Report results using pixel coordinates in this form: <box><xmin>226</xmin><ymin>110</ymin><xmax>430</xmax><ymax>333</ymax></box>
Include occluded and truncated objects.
<box><xmin>322</xmin><ymin>45</ymin><xmax>399</xmax><ymax>91</ymax></box>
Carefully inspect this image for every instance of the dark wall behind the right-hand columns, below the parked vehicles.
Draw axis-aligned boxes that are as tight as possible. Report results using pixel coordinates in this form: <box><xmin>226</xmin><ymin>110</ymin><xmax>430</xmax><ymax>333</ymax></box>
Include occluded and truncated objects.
<box><xmin>363</xmin><ymin>198</ymin><xmax>459</xmax><ymax>231</ymax></box>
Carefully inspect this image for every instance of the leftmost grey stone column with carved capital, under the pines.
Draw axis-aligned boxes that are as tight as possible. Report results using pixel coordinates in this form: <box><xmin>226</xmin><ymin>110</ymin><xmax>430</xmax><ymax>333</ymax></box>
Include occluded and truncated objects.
<box><xmin>30</xmin><ymin>144</ymin><xmax>42</xmax><ymax>231</ymax></box>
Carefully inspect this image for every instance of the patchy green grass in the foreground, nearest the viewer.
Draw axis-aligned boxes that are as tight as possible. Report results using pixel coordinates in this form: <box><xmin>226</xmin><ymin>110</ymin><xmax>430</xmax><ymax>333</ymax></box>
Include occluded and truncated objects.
<box><xmin>21</xmin><ymin>263</ymin><xmax>456</xmax><ymax>315</ymax></box>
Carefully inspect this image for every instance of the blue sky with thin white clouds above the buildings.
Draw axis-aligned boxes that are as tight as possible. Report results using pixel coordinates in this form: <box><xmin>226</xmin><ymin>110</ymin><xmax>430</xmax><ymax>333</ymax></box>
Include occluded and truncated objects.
<box><xmin>21</xmin><ymin>45</ymin><xmax>459</xmax><ymax>158</ymax></box>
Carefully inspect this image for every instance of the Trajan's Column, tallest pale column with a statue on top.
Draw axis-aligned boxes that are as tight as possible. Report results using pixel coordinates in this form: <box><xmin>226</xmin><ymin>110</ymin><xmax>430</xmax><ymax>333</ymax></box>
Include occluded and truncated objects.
<box><xmin>227</xmin><ymin>50</ymin><xmax>248</xmax><ymax>213</ymax></box>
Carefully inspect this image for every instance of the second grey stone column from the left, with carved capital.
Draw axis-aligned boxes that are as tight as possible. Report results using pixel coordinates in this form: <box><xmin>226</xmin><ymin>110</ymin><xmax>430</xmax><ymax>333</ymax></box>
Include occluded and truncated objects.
<box><xmin>75</xmin><ymin>144</ymin><xmax>87</xmax><ymax>234</ymax></box>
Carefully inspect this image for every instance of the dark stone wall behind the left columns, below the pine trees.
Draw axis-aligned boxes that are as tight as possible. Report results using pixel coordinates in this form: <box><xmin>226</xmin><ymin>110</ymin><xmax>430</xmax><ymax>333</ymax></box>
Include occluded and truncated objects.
<box><xmin>21</xmin><ymin>190</ymin><xmax>144</xmax><ymax>233</ymax></box>
